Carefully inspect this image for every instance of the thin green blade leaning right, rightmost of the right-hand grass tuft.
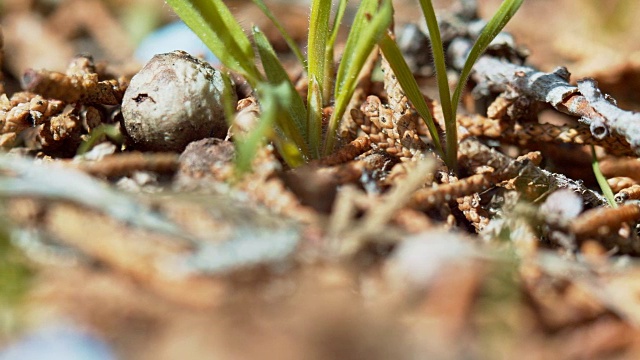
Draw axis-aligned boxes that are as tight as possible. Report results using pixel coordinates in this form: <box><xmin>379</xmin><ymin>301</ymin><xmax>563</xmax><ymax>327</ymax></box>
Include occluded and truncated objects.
<box><xmin>447</xmin><ymin>0</ymin><xmax>524</xmax><ymax>169</ymax></box>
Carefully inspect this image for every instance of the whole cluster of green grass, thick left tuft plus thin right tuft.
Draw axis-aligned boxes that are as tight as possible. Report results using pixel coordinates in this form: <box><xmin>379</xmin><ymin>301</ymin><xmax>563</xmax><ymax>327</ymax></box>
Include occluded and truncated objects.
<box><xmin>167</xmin><ymin>0</ymin><xmax>523</xmax><ymax>171</ymax></box>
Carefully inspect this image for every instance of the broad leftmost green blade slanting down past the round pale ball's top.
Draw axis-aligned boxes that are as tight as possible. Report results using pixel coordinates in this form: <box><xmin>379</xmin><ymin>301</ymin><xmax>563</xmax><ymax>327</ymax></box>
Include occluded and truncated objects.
<box><xmin>167</xmin><ymin>0</ymin><xmax>262</xmax><ymax>87</ymax></box>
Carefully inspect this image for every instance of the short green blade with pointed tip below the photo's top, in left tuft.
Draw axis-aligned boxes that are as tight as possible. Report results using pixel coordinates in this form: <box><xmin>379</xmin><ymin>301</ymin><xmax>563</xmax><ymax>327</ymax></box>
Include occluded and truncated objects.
<box><xmin>253</xmin><ymin>26</ymin><xmax>310</xmax><ymax>156</ymax></box>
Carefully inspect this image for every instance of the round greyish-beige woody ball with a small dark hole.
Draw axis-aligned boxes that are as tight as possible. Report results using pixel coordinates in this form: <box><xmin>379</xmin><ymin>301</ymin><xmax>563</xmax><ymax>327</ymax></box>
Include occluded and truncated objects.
<box><xmin>122</xmin><ymin>51</ymin><xmax>235</xmax><ymax>152</ymax></box>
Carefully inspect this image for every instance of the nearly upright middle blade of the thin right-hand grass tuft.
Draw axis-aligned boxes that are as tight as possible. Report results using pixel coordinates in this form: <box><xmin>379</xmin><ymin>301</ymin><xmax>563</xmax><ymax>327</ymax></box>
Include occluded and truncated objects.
<box><xmin>420</xmin><ymin>0</ymin><xmax>458</xmax><ymax>171</ymax></box>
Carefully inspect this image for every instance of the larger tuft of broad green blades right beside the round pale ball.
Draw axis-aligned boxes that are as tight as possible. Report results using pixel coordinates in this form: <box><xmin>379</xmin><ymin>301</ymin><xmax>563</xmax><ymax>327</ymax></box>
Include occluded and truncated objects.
<box><xmin>167</xmin><ymin>0</ymin><xmax>392</xmax><ymax>170</ymax></box>
